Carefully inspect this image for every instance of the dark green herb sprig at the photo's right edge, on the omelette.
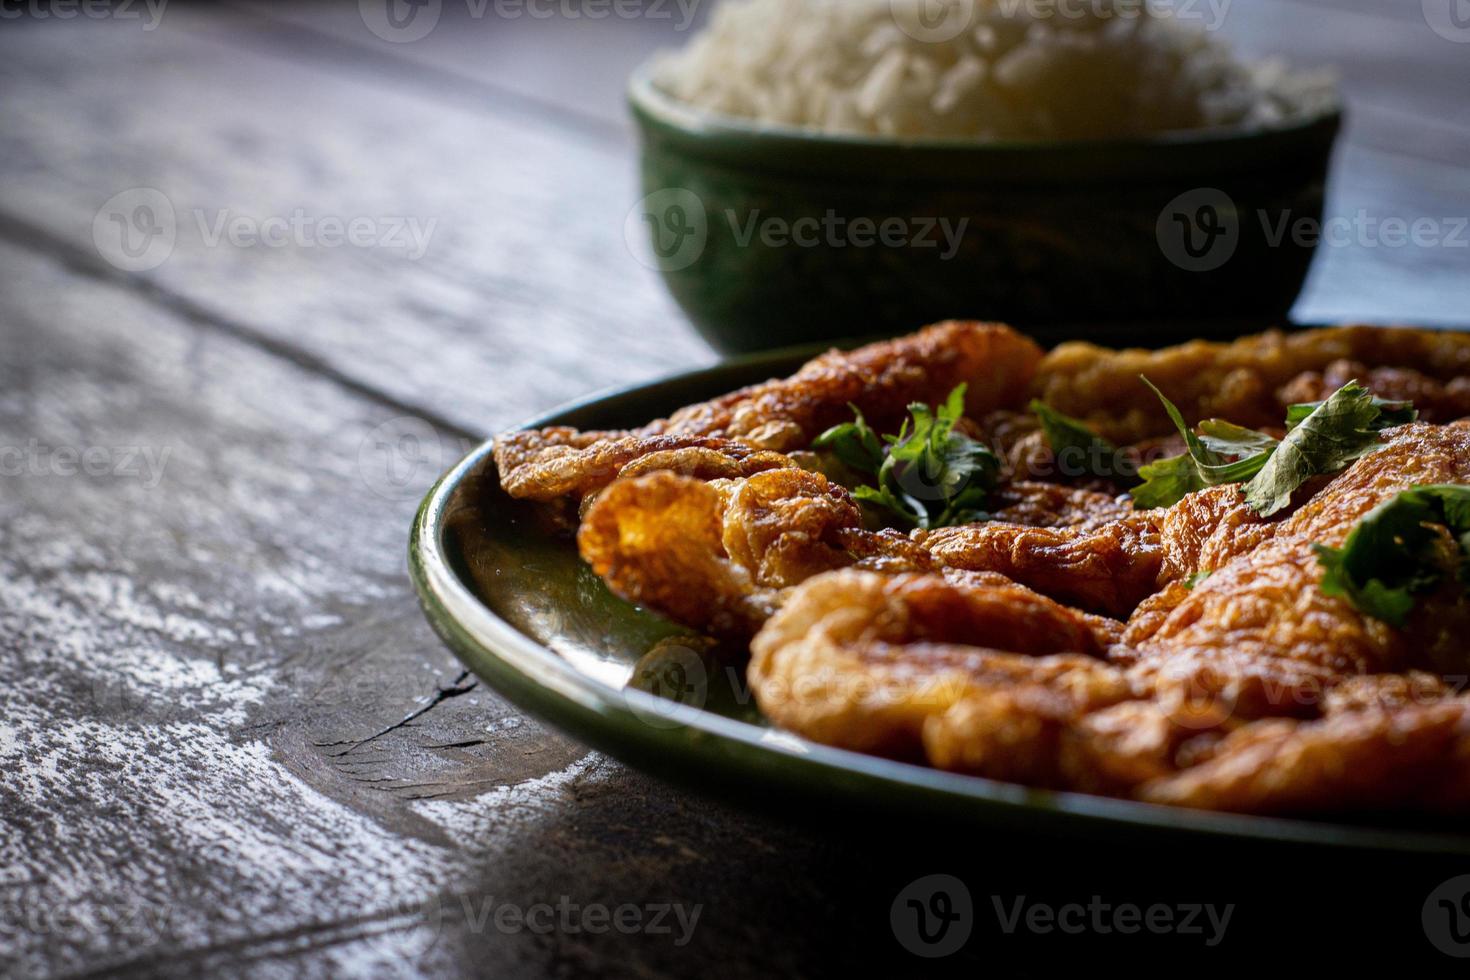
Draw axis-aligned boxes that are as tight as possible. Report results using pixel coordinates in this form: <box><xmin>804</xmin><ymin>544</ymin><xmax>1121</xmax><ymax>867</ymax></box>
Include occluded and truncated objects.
<box><xmin>1311</xmin><ymin>485</ymin><xmax>1470</xmax><ymax>627</ymax></box>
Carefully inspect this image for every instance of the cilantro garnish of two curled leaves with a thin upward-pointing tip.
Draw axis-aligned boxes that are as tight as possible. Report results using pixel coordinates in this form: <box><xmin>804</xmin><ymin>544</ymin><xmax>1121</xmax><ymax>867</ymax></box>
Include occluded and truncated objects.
<box><xmin>1133</xmin><ymin>378</ymin><xmax>1417</xmax><ymax>517</ymax></box>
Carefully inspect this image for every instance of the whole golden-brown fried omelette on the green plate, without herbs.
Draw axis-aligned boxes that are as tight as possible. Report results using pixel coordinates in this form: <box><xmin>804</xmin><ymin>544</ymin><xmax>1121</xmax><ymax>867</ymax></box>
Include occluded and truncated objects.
<box><xmin>495</xmin><ymin>322</ymin><xmax>1470</xmax><ymax>814</ymax></box>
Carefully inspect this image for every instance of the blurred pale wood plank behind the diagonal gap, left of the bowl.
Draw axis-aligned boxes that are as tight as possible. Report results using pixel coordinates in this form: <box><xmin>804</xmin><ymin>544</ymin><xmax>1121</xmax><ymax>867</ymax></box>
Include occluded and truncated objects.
<box><xmin>0</xmin><ymin>9</ymin><xmax>713</xmax><ymax>432</ymax></box>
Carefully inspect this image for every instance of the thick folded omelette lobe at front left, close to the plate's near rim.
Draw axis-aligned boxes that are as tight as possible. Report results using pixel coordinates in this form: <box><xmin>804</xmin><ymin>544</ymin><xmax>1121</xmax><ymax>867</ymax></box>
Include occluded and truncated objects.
<box><xmin>748</xmin><ymin>569</ymin><xmax>1135</xmax><ymax>758</ymax></box>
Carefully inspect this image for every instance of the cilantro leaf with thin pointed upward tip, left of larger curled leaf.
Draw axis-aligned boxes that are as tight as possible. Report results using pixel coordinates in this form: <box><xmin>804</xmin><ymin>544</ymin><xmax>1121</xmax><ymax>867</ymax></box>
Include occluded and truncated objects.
<box><xmin>1133</xmin><ymin>378</ymin><xmax>1276</xmax><ymax>510</ymax></box>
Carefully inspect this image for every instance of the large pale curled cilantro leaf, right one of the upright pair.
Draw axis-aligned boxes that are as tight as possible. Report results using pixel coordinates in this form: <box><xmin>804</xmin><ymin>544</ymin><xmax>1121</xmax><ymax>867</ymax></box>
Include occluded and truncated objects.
<box><xmin>1244</xmin><ymin>382</ymin><xmax>1382</xmax><ymax>517</ymax></box>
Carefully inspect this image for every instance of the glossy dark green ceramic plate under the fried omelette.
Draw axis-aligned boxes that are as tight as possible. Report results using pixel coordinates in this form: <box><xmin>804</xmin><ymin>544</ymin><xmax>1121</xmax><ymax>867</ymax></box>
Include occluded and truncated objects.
<box><xmin>409</xmin><ymin>340</ymin><xmax>1470</xmax><ymax>854</ymax></box>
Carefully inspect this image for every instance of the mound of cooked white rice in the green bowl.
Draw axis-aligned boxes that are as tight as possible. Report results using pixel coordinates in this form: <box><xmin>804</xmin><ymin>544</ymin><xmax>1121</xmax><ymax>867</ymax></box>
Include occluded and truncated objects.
<box><xmin>654</xmin><ymin>0</ymin><xmax>1335</xmax><ymax>140</ymax></box>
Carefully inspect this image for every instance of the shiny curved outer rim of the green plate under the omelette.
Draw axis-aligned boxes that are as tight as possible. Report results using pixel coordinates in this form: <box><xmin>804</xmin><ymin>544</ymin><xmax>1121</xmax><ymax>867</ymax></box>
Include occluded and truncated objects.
<box><xmin>409</xmin><ymin>344</ymin><xmax>1470</xmax><ymax>854</ymax></box>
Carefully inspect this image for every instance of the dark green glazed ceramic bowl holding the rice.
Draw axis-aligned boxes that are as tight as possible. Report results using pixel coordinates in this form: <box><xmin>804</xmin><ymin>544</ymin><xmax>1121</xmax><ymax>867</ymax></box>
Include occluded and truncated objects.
<box><xmin>629</xmin><ymin>69</ymin><xmax>1342</xmax><ymax>351</ymax></box>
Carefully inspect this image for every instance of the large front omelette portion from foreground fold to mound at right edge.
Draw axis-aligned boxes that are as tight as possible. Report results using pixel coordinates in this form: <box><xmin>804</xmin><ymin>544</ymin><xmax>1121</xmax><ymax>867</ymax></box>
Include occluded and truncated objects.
<box><xmin>751</xmin><ymin>423</ymin><xmax>1470</xmax><ymax>813</ymax></box>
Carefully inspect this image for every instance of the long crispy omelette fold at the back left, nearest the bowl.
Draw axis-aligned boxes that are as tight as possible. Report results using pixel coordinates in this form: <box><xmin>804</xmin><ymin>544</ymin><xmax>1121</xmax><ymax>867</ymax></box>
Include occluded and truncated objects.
<box><xmin>494</xmin><ymin>320</ymin><xmax>1042</xmax><ymax>501</ymax></box>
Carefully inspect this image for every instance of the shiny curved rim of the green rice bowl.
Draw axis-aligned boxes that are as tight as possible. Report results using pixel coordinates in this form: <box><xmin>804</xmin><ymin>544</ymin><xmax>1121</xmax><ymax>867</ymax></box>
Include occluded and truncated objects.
<box><xmin>626</xmin><ymin>61</ymin><xmax>1345</xmax><ymax>154</ymax></box>
